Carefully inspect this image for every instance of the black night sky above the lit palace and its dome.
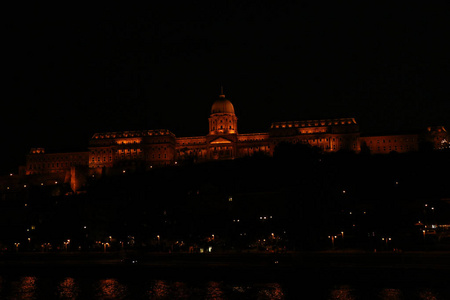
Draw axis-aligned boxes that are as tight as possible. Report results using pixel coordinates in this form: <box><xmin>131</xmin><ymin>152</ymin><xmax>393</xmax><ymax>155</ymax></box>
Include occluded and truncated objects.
<box><xmin>0</xmin><ymin>0</ymin><xmax>450</xmax><ymax>174</ymax></box>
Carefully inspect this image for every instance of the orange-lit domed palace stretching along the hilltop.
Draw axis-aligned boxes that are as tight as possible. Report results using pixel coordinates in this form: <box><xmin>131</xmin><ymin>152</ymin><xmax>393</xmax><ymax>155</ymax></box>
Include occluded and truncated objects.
<box><xmin>7</xmin><ymin>90</ymin><xmax>449</xmax><ymax>190</ymax></box>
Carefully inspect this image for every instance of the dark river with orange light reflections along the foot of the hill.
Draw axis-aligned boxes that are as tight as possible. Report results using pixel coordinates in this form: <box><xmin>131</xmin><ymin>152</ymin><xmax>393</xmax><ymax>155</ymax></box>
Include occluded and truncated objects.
<box><xmin>0</xmin><ymin>253</ymin><xmax>450</xmax><ymax>299</ymax></box>
